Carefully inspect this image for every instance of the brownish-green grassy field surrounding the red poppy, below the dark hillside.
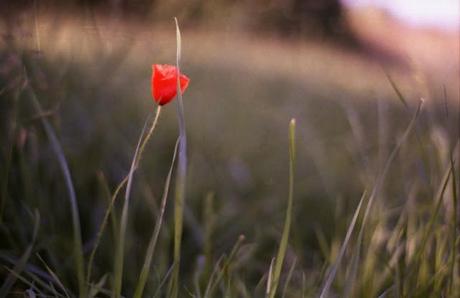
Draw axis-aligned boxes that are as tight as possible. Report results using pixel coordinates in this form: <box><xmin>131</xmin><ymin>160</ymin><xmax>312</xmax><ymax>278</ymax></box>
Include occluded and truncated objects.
<box><xmin>0</xmin><ymin>9</ymin><xmax>460</xmax><ymax>297</ymax></box>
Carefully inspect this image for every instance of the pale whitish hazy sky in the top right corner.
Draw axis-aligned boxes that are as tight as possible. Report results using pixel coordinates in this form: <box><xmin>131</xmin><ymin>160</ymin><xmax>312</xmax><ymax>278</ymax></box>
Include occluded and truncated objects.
<box><xmin>342</xmin><ymin>0</ymin><xmax>460</xmax><ymax>29</ymax></box>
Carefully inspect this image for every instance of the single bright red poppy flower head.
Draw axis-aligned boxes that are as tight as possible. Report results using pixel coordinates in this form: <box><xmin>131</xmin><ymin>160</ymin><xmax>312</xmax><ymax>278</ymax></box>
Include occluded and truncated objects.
<box><xmin>152</xmin><ymin>64</ymin><xmax>190</xmax><ymax>106</ymax></box>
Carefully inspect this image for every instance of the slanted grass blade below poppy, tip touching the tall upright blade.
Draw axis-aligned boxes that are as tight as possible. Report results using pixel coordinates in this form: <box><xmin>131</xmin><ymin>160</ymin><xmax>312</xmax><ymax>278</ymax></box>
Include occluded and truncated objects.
<box><xmin>134</xmin><ymin>139</ymin><xmax>179</xmax><ymax>298</ymax></box>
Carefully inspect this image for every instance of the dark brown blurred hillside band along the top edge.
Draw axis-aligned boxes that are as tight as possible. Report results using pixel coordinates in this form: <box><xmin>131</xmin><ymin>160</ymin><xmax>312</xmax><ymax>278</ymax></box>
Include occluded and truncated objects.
<box><xmin>0</xmin><ymin>0</ymin><xmax>352</xmax><ymax>41</ymax></box>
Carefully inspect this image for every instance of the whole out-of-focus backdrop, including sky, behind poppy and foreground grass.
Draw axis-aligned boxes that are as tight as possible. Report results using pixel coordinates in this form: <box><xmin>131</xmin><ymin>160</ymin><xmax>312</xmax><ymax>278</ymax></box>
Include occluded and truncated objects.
<box><xmin>0</xmin><ymin>0</ymin><xmax>460</xmax><ymax>296</ymax></box>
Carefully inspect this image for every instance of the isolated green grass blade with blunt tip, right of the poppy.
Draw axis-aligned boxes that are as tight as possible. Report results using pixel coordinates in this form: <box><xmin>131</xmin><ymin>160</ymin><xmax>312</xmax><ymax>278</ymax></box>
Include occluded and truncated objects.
<box><xmin>268</xmin><ymin>119</ymin><xmax>296</xmax><ymax>298</ymax></box>
